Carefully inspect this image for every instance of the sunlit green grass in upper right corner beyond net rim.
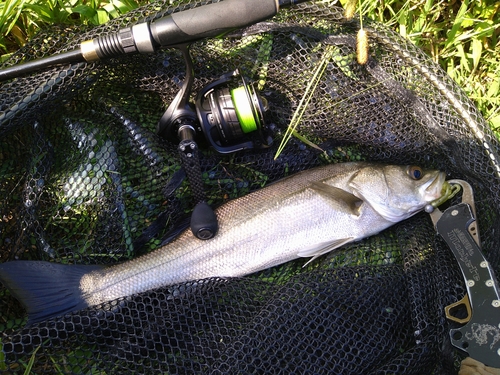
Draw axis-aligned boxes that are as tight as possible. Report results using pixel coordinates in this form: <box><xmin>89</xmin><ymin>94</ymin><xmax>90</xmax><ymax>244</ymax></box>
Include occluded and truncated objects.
<box><xmin>341</xmin><ymin>0</ymin><xmax>500</xmax><ymax>134</ymax></box>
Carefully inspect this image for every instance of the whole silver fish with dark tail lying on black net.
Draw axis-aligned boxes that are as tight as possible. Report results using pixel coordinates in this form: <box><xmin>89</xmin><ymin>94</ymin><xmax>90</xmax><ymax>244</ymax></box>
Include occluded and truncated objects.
<box><xmin>0</xmin><ymin>162</ymin><xmax>446</xmax><ymax>323</ymax></box>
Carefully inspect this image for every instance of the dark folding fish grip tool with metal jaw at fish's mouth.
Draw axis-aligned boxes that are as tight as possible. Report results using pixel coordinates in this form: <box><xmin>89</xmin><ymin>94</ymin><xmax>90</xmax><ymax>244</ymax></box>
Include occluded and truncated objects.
<box><xmin>430</xmin><ymin>180</ymin><xmax>500</xmax><ymax>367</ymax></box>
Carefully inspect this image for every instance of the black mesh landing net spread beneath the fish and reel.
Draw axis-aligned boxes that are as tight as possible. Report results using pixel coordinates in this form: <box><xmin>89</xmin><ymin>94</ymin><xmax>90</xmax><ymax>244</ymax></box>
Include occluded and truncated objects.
<box><xmin>0</xmin><ymin>0</ymin><xmax>500</xmax><ymax>374</ymax></box>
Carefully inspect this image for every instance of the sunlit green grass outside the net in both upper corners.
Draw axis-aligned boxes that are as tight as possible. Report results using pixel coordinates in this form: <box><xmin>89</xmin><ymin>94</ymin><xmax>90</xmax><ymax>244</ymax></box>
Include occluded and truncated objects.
<box><xmin>0</xmin><ymin>0</ymin><xmax>500</xmax><ymax>134</ymax></box>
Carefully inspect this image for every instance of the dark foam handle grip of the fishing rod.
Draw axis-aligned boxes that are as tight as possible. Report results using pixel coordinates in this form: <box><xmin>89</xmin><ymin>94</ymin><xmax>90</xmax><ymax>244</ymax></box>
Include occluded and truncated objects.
<box><xmin>150</xmin><ymin>0</ymin><xmax>278</xmax><ymax>47</ymax></box>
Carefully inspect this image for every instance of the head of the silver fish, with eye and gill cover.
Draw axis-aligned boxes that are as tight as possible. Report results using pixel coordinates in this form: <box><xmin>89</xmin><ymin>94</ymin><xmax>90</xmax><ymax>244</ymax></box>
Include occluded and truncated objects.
<box><xmin>349</xmin><ymin>165</ymin><xmax>446</xmax><ymax>223</ymax></box>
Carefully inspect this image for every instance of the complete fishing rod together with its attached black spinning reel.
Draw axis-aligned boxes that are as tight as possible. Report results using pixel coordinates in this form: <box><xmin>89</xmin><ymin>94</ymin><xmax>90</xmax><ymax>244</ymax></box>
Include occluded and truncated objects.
<box><xmin>0</xmin><ymin>0</ymin><xmax>308</xmax><ymax>240</ymax></box>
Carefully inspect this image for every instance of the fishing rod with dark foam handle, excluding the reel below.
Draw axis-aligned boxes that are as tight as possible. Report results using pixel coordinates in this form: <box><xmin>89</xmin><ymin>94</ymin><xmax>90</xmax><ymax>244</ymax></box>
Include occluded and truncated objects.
<box><xmin>0</xmin><ymin>0</ymin><xmax>308</xmax><ymax>81</ymax></box>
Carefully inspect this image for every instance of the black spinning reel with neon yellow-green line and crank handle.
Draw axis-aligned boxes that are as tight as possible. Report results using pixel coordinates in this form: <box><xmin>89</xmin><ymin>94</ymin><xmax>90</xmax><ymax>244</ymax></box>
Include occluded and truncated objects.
<box><xmin>157</xmin><ymin>45</ymin><xmax>272</xmax><ymax>240</ymax></box>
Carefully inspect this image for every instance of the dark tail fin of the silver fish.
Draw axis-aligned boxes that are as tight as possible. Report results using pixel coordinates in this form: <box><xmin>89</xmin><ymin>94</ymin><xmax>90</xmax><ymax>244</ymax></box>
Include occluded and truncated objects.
<box><xmin>0</xmin><ymin>261</ymin><xmax>102</xmax><ymax>324</ymax></box>
